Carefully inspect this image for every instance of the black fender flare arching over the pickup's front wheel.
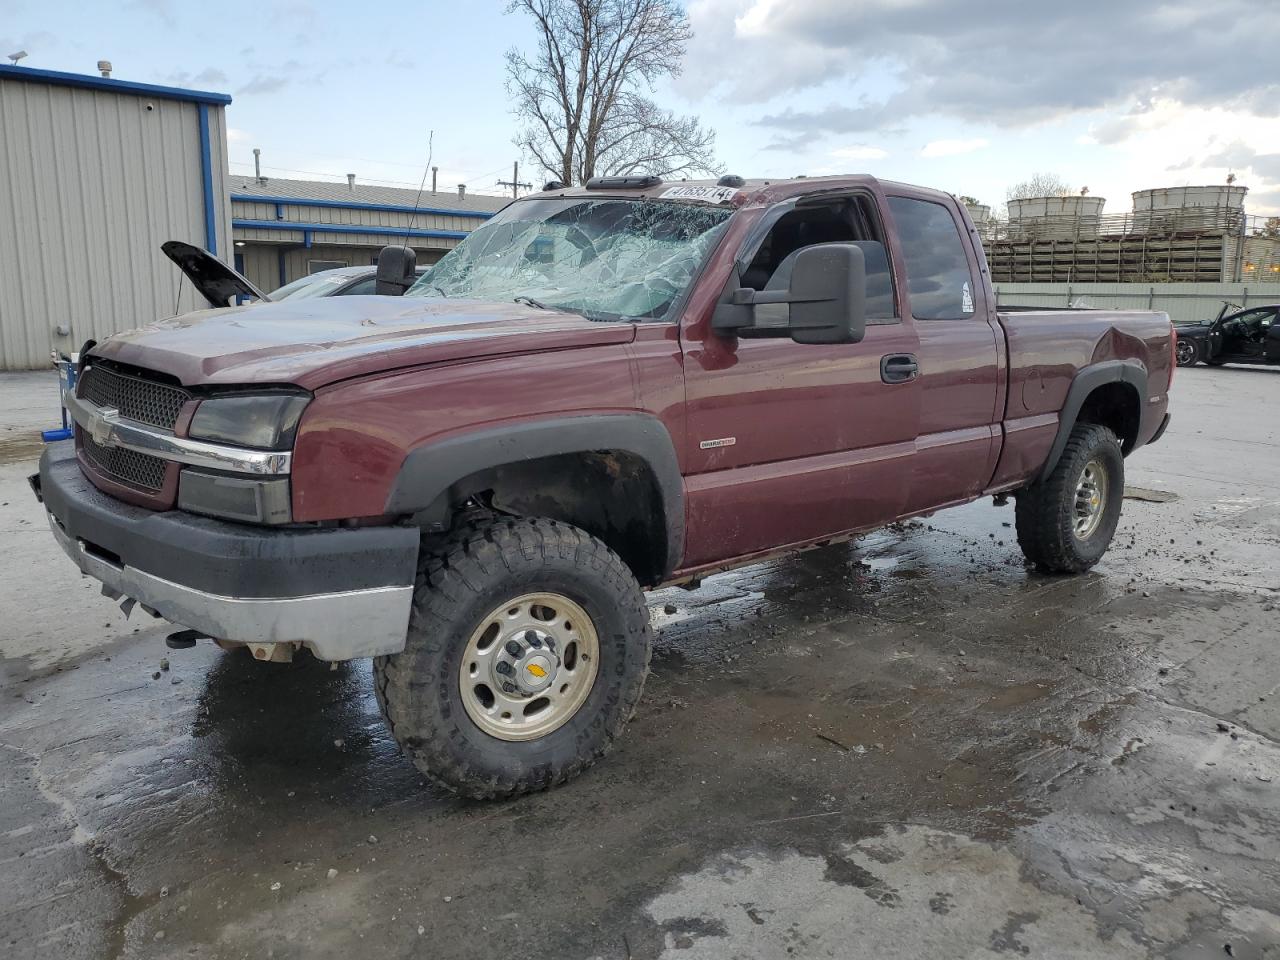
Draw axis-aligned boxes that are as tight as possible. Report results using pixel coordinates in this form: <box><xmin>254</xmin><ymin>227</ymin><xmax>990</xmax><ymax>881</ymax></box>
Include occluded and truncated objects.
<box><xmin>387</xmin><ymin>413</ymin><xmax>685</xmax><ymax>575</ymax></box>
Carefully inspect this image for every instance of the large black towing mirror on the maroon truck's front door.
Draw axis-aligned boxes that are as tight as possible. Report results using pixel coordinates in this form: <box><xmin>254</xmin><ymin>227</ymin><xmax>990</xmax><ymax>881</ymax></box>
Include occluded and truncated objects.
<box><xmin>712</xmin><ymin>243</ymin><xmax>881</xmax><ymax>343</ymax></box>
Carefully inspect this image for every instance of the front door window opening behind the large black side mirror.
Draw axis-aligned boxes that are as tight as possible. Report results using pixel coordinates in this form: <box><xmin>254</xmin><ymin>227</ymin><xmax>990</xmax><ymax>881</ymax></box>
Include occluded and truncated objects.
<box><xmin>740</xmin><ymin>198</ymin><xmax>897</xmax><ymax>320</ymax></box>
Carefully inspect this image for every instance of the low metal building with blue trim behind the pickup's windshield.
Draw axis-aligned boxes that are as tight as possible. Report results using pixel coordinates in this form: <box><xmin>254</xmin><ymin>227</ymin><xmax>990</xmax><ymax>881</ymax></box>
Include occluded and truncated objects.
<box><xmin>228</xmin><ymin>174</ymin><xmax>511</xmax><ymax>291</ymax></box>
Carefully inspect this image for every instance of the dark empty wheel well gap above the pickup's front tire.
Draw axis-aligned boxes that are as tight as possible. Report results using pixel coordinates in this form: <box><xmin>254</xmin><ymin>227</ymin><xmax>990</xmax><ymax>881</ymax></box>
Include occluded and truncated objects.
<box><xmin>437</xmin><ymin>451</ymin><xmax>668</xmax><ymax>586</ymax></box>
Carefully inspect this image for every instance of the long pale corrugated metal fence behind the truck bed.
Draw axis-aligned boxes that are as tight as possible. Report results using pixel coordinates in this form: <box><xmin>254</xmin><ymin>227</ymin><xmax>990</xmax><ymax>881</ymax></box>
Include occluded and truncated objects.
<box><xmin>996</xmin><ymin>283</ymin><xmax>1280</xmax><ymax>323</ymax></box>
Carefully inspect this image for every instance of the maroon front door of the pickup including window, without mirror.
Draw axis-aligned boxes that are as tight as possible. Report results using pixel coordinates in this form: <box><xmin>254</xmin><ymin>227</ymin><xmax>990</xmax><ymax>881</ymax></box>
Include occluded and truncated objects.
<box><xmin>681</xmin><ymin>198</ymin><xmax>920</xmax><ymax>567</ymax></box>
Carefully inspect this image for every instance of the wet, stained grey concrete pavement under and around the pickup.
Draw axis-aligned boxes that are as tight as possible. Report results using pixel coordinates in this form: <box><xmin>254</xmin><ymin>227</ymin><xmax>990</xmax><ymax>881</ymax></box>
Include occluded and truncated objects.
<box><xmin>0</xmin><ymin>367</ymin><xmax>1280</xmax><ymax>959</ymax></box>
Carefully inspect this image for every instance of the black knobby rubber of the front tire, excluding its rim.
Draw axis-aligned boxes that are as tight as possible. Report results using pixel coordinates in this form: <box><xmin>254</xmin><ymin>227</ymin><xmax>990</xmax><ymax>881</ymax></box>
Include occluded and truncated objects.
<box><xmin>374</xmin><ymin>517</ymin><xmax>653</xmax><ymax>799</ymax></box>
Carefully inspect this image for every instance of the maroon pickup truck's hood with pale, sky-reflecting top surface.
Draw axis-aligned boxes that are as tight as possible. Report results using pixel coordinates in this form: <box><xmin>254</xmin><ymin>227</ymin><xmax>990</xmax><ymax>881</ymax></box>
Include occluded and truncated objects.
<box><xmin>92</xmin><ymin>297</ymin><xmax>635</xmax><ymax>389</ymax></box>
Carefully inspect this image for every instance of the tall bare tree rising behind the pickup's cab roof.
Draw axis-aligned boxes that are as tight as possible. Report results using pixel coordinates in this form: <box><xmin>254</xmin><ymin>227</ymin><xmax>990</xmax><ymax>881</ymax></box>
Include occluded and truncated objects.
<box><xmin>507</xmin><ymin>0</ymin><xmax>718</xmax><ymax>183</ymax></box>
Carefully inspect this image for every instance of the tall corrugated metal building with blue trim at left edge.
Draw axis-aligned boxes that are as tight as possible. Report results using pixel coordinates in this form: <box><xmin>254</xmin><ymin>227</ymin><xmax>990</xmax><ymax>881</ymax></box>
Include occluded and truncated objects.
<box><xmin>0</xmin><ymin>67</ymin><xmax>232</xmax><ymax>370</ymax></box>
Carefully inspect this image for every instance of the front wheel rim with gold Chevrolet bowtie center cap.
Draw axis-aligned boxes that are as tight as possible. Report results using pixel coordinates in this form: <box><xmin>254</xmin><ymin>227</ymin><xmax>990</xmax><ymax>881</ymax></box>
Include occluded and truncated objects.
<box><xmin>458</xmin><ymin>594</ymin><xmax>600</xmax><ymax>740</ymax></box>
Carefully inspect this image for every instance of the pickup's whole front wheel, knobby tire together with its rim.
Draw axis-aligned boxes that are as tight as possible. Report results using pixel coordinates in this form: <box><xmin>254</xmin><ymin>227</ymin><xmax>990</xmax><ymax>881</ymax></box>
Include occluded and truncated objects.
<box><xmin>374</xmin><ymin>517</ymin><xmax>652</xmax><ymax>799</ymax></box>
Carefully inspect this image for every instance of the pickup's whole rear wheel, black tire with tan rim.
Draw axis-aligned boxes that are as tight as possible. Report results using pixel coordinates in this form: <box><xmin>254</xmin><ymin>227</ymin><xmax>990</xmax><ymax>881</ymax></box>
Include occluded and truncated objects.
<box><xmin>1015</xmin><ymin>424</ymin><xmax>1124</xmax><ymax>573</ymax></box>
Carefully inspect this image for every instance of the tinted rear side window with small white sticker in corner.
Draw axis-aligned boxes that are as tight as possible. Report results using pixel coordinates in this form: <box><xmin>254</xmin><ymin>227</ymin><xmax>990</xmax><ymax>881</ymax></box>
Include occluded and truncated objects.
<box><xmin>888</xmin><ymin>197</ymin><xmax>977</xmax><ymax>320</ymax></box>
